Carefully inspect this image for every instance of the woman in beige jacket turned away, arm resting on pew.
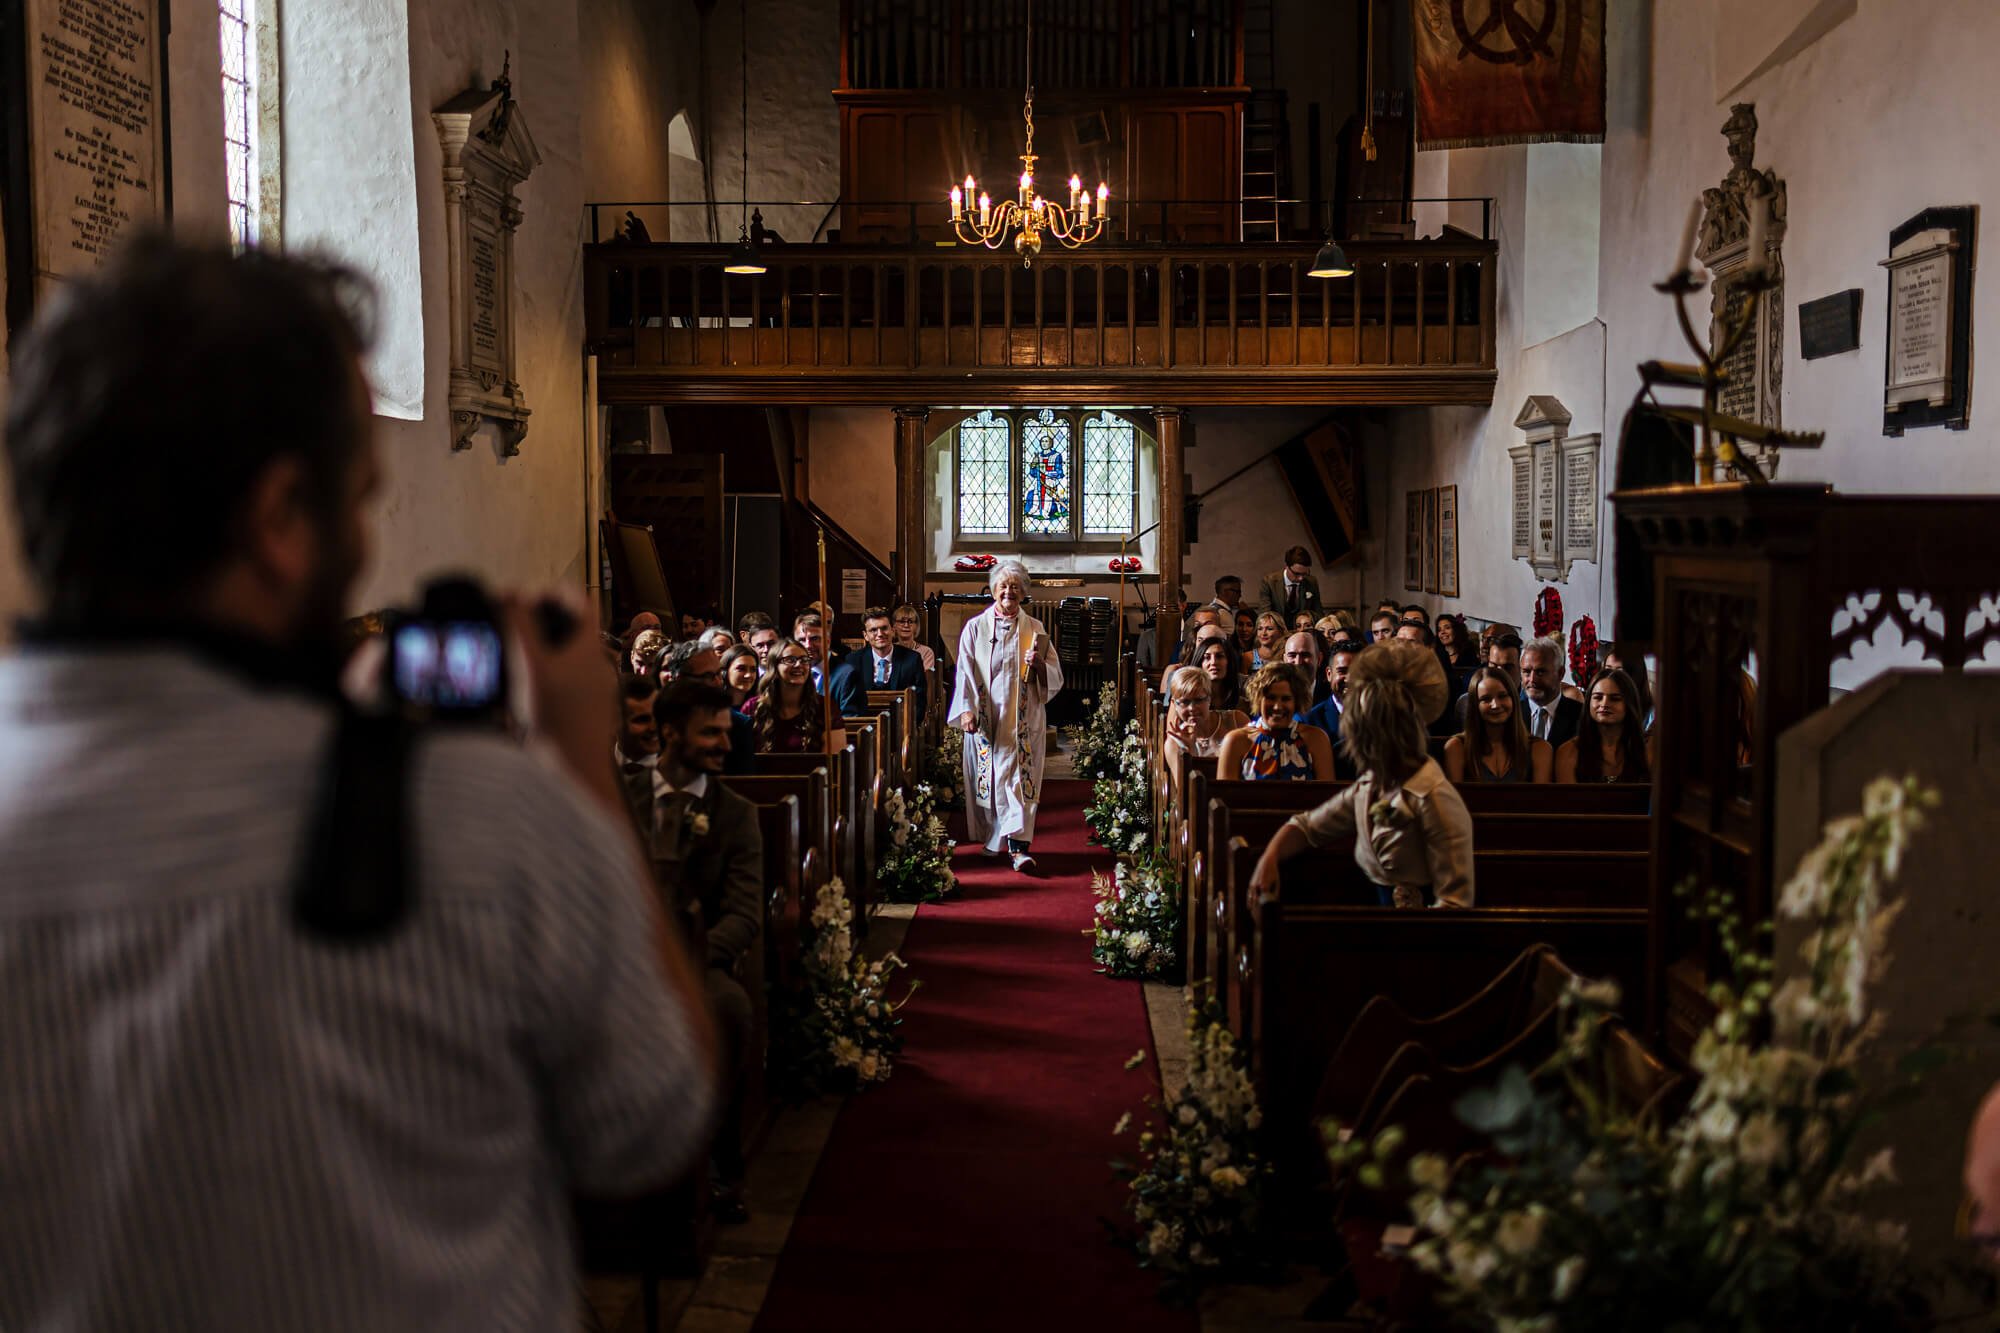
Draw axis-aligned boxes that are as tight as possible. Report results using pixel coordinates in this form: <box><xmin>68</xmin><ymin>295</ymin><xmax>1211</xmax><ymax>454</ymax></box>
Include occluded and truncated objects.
<box><xmin>1250</xmin><ymin>642</ymin><xmax>1472</xmax><ymax>907</ymax></box>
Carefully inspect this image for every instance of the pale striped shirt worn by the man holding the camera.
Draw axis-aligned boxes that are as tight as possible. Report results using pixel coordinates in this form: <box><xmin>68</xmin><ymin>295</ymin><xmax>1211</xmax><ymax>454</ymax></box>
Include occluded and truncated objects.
<box><xmin>0</xmin><ymin>648</ymin><xmax>714</xmax><ymax>1333</ymax></box>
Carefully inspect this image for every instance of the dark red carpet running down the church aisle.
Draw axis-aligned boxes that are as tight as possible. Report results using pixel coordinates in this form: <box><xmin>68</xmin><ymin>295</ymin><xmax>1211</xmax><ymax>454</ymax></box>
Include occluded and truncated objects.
<box><xmin>756</xmin><ymin>781</ymin><xmax>1194</xmax><ymax>1333</ymax></box>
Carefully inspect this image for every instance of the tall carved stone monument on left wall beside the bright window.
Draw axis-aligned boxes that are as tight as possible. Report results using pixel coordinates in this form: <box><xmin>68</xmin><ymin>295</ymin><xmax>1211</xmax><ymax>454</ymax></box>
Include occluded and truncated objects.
<box><xmin>430</xmin><ymin>59</ymin><xmax>542</xmax><ymax>454</ymax></box>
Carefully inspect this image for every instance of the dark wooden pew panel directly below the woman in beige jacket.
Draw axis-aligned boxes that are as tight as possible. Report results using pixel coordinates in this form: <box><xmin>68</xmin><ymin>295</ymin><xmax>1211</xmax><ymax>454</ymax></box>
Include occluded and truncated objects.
<box><xmin>1230</xmin><ymin>901</ymin><xmax>1648</xmax><ymax>1179</ymax></box>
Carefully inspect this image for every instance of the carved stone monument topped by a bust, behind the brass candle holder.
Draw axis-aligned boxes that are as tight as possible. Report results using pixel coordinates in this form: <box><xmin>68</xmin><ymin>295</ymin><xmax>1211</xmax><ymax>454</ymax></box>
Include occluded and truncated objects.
<box><xmin>1694</xmin><ymin>102</ymin><xmax>1786</xmax><ymax>462</ymax></box>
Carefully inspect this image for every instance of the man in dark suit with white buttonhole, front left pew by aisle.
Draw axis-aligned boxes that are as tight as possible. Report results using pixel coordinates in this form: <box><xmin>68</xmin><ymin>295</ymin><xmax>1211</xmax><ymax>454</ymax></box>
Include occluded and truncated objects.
<box><xmin>650</xmin><ymin>679</ymin><xmax>764</xmax><ymax>1223</ymax></box>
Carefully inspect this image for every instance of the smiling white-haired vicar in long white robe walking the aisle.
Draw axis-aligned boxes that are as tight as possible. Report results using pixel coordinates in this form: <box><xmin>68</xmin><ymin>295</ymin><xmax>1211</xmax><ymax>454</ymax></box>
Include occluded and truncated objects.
<box><xmin>950</xmin><ymin>560</ymin><xmax>1062</xmax><ymax>873</ymax></box>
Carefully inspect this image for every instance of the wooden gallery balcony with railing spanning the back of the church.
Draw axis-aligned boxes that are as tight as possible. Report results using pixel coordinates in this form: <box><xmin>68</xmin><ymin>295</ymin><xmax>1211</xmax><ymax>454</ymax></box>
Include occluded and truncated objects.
<box><xmin>584</xmin><ymin>204</ymin><xmax>1498</xmax><ymax>406</ymax></box>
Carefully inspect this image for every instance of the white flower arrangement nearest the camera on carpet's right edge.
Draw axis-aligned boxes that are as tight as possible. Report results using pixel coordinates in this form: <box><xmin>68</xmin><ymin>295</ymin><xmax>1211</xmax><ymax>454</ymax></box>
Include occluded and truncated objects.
<box><xmin>1112</xmin><ymin>993</ymin><xmax>1274</xmax><ymax>1303</ymax></box>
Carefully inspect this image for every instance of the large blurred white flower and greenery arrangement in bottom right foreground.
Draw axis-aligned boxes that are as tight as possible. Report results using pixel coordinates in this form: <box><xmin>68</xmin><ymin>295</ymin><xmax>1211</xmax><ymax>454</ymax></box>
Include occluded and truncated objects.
<box><xmin>1322</xmin><ymin>779</ymin><xmax>1964</xmax><ymax>1331</ymax></box>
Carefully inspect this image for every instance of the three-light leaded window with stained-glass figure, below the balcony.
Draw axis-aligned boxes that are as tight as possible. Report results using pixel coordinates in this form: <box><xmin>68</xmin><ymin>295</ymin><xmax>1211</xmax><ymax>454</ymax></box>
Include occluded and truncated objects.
<box><xmin>954</xmin><ymin>408</ymin><xmax>1138</xmax><ymax>542</ymax></box>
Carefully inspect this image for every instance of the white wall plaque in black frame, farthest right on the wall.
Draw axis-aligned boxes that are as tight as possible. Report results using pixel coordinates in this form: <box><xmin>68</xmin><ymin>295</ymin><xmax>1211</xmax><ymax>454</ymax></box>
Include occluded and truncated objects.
<box><xmin>1882</xmin><ymin>208</ymin><xmax>1974</xmax><ymax>434</ymax></box>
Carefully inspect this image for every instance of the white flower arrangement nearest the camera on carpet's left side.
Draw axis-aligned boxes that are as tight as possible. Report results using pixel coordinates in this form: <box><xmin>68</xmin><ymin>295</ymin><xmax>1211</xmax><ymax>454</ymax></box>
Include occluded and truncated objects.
<box><xmin>772</xmin><ymin>879</ymin><xmax>922</xmax><ymax>1097</ymax></box>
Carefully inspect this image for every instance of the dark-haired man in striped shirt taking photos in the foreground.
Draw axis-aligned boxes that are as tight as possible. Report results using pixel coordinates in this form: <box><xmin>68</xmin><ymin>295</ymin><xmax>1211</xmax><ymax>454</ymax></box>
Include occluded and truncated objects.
<box><xmin>0</xmin><ymin>238</ymin><xmax>714</xmax><ymax>1333</ymax></box>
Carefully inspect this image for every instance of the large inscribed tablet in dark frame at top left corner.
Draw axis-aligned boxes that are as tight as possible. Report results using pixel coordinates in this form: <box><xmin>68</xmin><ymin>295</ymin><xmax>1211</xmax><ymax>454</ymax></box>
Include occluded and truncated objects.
<box><xmin>0</xmin><ymin>0</ymin><xmax>170</xmax><ymax>334</ymax></box>
